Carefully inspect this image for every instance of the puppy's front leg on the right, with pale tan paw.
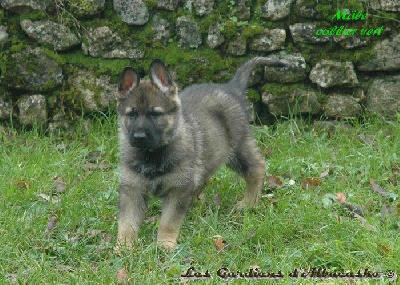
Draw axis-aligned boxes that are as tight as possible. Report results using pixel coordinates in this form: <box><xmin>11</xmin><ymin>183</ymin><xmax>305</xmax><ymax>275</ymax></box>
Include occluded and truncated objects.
<box><xmin>157</xmin><ymin>189</ymin><xmax>193</xmax><ymax>250</ymax></box>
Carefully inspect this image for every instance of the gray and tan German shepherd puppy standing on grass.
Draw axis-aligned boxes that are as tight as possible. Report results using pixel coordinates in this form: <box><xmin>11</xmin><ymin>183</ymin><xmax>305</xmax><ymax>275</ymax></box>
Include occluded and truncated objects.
<box><xmin>117</xmin><ymin>57</ymin><xmax>283</xmax><ymax>249</ymax></box>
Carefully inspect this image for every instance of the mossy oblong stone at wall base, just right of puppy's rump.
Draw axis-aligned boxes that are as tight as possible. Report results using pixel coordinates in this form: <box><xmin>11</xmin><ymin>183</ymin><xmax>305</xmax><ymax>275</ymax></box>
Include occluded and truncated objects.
<box><xmin>261</xmin><ymin>89</ymin><xmax>321</xmax><ymax>116</ymax></box>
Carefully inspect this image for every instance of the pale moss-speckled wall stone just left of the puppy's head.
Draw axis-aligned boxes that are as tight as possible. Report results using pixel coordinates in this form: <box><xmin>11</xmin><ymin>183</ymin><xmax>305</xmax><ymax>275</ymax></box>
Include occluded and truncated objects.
<box><xmin>69</xmin><ymin>70</ymin><xmax>117</xmax><ymax>113</ymax></box>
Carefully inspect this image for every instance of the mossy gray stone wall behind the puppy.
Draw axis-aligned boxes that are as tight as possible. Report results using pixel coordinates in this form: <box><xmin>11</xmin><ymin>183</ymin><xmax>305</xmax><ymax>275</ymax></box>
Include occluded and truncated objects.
<box><xmin>0</xmin><ymin>0</ymin><xmax>400</xmax><ymax>130</ymax></box>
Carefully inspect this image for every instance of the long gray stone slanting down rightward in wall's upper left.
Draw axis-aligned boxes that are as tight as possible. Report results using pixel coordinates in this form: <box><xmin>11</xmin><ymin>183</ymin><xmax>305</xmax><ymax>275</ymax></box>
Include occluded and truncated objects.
<box><xmin>21</xmin><ymin>20</ymin><xmax>80</xmax><ymax>51</ymax></box>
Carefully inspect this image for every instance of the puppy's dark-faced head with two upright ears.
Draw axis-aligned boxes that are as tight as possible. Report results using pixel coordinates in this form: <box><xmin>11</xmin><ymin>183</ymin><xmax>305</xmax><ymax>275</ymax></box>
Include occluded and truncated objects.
<box><xmin>117</xmin><ymin>59</ymin><xmax>180</xmax><ymax>149</ymax></box>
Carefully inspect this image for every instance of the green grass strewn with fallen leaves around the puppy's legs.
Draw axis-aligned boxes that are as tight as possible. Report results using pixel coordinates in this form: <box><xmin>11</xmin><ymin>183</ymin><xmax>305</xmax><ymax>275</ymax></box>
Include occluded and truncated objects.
<box><xmin>0</xmin><ymin>114</ymin><xmax>400</xmax><ymax>284</ymax></box>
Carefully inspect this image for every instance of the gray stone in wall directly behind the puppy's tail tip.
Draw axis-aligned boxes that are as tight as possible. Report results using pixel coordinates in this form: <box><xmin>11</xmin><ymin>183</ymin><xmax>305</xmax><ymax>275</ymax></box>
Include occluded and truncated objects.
<box><xmin>265</xmin><ymin>51</ymin><xmax>307</xmax><ymax>83</ymax></box>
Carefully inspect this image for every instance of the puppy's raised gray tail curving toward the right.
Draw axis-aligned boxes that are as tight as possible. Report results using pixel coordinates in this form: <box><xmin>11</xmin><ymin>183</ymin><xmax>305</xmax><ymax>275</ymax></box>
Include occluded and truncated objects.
<box><xmin>229</xmin><ymin>57</ymin><xmax>286</xmax><ymax>90</ymax></box>
